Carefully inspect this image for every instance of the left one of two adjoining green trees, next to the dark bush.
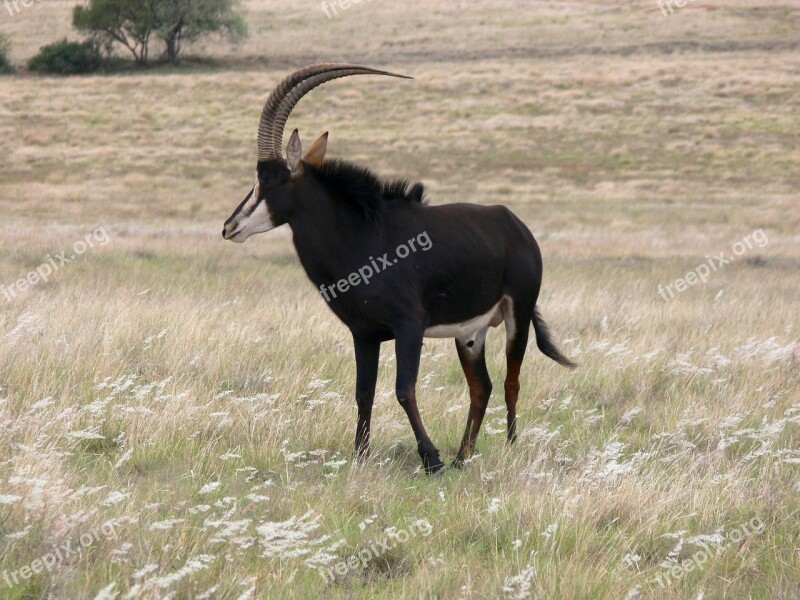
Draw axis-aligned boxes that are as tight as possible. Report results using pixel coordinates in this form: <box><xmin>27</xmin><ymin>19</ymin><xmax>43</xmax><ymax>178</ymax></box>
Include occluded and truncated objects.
<box><xmin>72</xmin><ymin>0</ymin><xmax>158</xmax><ymax>66</ymax></box>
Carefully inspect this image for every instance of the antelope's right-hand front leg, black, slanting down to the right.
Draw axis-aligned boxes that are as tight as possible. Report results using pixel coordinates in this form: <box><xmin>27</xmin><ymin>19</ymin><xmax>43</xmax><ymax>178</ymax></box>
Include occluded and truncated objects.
<box><xmin>395</xmin><ymin>330</ymin><xmax>444</xmax><ymax>473</ymax></box>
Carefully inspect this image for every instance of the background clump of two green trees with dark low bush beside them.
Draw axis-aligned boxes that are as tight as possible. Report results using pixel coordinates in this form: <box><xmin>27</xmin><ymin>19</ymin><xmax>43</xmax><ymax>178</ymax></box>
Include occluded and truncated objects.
<box><xmin>24</xmin><ymin>0</ymin><xmax>247</xmax><ymax>74</ymax></box>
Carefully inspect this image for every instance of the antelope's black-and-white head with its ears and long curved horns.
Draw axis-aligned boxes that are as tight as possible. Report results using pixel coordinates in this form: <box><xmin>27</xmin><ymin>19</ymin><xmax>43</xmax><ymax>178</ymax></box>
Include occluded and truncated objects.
<box><xmin>222</xmin><ymin>63</ymin><xmax>411</xmax><ymax>243</ymax></box>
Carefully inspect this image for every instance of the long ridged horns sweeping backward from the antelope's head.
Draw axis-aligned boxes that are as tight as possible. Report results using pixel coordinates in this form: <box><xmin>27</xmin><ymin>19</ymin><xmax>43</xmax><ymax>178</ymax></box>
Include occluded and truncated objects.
<box><xmin>258</xmin><ymin>63</ymin><xmax>412</xmax><ymax>162</ymax></box>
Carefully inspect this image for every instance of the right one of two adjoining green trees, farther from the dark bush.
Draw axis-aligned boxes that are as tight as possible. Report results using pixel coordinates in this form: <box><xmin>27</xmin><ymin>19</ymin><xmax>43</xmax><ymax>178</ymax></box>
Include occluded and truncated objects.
<box><xmin>156</xmin><ymin>0</ymin><xmax>247</xmax><ymax>64</ymax></box>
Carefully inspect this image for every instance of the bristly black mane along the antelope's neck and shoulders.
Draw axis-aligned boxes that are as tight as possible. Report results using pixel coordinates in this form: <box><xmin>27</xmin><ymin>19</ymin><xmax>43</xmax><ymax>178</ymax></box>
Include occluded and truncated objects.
<box><xmin>312</xmin><ymin>160</ymin><xmax>428</xmax><ymax>219</ymax></box>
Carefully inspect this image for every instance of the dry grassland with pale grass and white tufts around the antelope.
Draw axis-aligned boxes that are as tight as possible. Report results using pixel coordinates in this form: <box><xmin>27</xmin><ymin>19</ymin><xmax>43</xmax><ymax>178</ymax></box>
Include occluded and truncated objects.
<box><xmin>0</xmin><ymin>0</ymin><xmax>800</xmax><ymax>599</ymax></box>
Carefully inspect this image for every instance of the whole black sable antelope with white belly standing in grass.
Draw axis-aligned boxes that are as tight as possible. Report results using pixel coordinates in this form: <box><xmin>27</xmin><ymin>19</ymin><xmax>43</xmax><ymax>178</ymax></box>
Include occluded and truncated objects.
<box><xmin>222</xmin><ymin>64</ymin><xmax>575</xmax><ymax>473</ymax></box>
